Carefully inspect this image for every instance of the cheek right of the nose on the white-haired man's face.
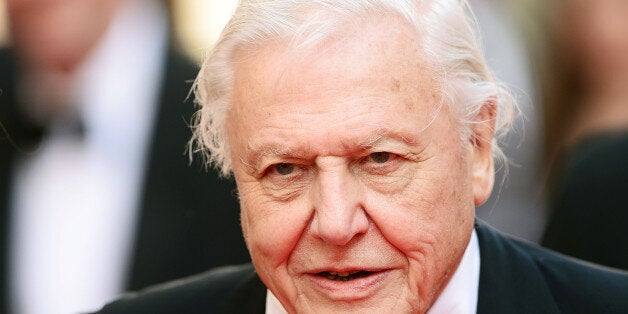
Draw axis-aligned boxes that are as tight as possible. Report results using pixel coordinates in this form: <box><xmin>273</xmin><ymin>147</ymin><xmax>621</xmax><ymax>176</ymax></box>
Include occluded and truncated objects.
<box><xmin>367</xmin><ymin>156</ymin><xmax>474</xmax><ymax>260</ymax></box>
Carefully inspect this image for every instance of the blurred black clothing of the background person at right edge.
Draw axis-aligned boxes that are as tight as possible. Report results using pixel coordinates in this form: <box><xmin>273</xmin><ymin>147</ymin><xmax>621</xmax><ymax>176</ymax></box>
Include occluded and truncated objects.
<box><xmin>542</xmin><ymin>133</ymin><xmax>628</xmax><ymax>270</ymax></box>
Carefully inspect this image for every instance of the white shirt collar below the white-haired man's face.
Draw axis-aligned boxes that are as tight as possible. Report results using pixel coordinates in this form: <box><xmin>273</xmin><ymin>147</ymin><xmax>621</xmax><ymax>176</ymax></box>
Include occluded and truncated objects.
<box><xmin>266</xmin><ymin>230</ymin><xmax>480</xmax><ymax>314</ymax></box>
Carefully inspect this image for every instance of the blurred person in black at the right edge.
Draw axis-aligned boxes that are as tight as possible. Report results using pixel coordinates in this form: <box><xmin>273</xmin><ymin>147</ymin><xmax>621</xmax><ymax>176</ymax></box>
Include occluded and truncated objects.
<box><xmin>537</xmin><ymin>0</ymin><xmax>628</xmax><ymax>269</ymax></box>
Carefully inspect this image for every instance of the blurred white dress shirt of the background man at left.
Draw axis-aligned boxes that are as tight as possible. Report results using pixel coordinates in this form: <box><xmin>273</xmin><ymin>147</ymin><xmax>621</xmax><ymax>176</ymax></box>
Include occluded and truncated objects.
<box><xmin>9</xmin><ymin>0</ymin><xmax>167</xmax><ymax>314</ymax></box>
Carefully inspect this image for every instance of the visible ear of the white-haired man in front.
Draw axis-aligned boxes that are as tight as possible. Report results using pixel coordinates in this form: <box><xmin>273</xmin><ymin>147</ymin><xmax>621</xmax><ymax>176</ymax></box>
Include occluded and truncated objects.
<box><xmin>469</xmin><ymin>98</ymin><xmax>497</xmax><ymax>206</ymax></box>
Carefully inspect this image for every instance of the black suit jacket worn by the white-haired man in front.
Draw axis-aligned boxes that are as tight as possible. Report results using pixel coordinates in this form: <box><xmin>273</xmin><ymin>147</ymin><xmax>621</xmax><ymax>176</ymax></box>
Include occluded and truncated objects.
<box><xmin>94</xmin><ymin>222</ymin><xmax>628</xmax><ymax>314</ymax></box>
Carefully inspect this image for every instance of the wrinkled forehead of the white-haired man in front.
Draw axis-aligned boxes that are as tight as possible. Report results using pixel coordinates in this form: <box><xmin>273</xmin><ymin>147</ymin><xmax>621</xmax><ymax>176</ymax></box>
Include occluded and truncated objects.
<box><xmin>229</xmin><ymin>15</ymin><xmax>440</xmax><ymax>158</ymax></box>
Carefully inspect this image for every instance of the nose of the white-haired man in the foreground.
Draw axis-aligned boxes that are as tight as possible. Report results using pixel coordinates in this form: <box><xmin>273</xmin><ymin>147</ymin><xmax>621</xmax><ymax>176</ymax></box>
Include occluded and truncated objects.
<box><xmin>310</xmin><ymin>158</ymin><xmax>370</xmax><ymax>246</ymax></box>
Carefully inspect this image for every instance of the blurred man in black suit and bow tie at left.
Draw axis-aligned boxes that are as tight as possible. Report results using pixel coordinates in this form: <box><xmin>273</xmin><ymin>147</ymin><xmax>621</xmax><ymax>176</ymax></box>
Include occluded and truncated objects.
<box><xmin>0</xmin><ymin>0</ymin><xmax>249</xmax><ymax>313</ymax></box>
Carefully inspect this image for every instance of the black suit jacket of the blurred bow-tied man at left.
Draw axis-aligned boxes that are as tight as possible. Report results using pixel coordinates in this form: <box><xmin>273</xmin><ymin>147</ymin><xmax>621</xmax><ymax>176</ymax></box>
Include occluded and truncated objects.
<box><xmin>0</xmin><ymin>45</ymin><xmax>250</xmax><ymax>313</ymax></box>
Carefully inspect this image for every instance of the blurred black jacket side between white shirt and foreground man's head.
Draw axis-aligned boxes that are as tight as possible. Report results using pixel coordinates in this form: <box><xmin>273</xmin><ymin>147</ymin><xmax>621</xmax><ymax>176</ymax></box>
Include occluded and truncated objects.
<box><xmin>127</xmin><ymin>48</ymin><xmax>249</xmax><ymax>290</ymax></box>
